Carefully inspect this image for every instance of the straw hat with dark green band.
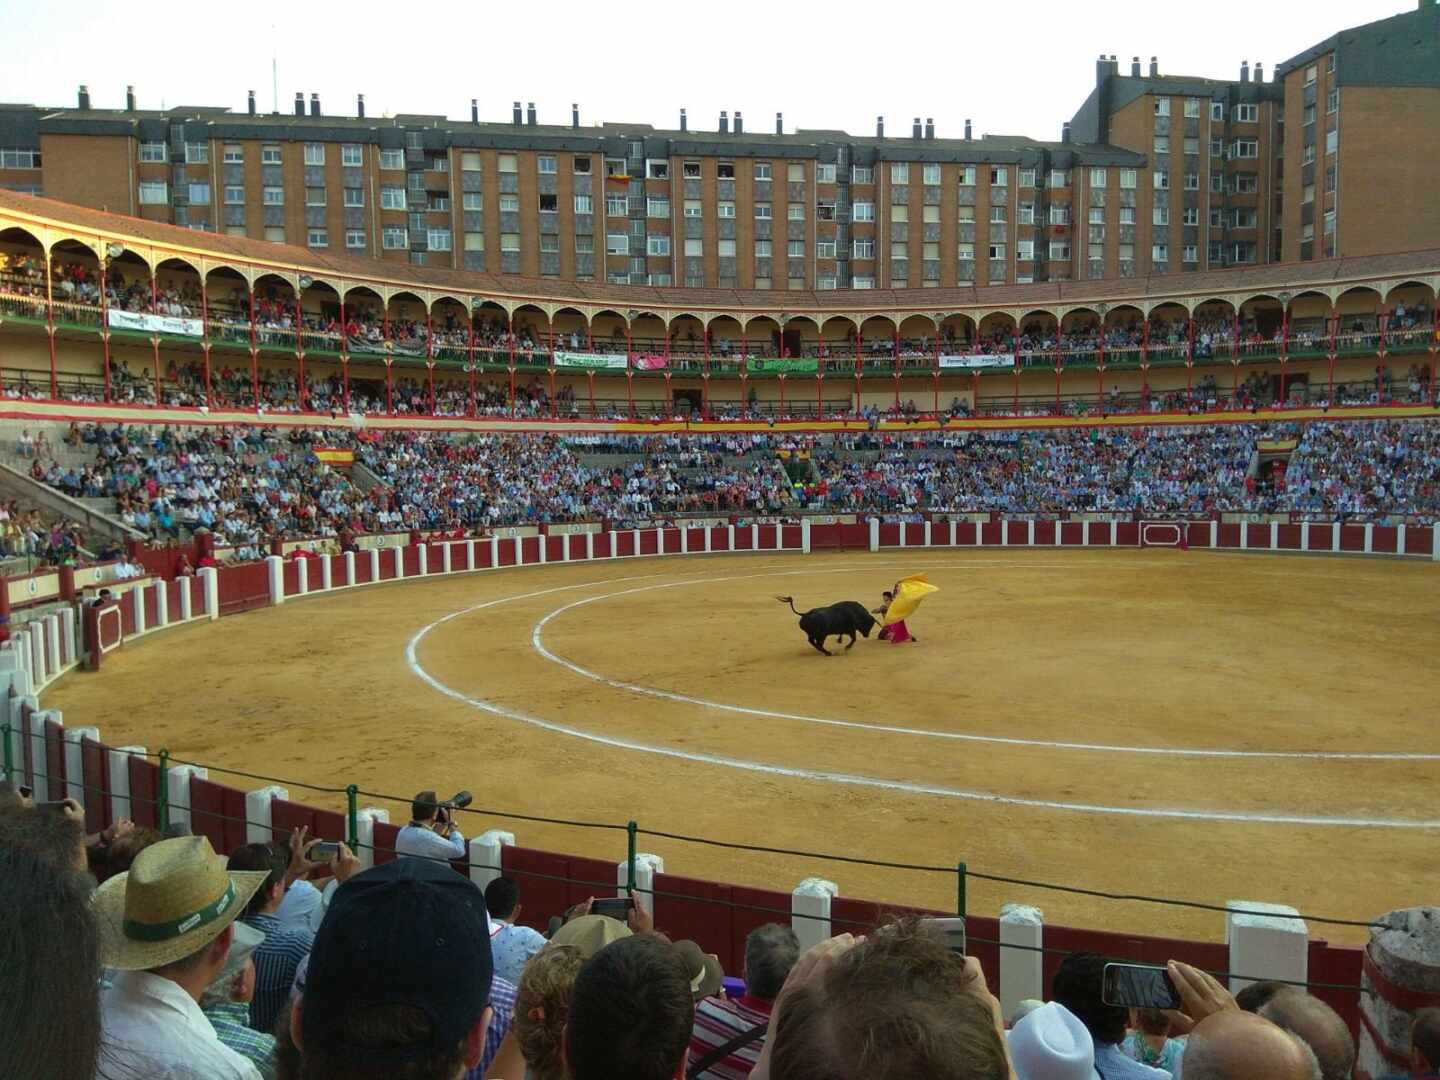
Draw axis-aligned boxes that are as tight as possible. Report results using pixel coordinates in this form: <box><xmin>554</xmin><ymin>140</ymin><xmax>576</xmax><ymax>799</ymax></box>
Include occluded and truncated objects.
<box><xmin>94</xmin><ymin>837</ymin><xmax>269</xmax><ymax>971</ymax></box>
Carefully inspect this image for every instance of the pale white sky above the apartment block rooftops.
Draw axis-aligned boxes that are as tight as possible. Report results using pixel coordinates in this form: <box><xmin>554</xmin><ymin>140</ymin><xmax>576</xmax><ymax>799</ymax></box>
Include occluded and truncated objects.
<box><xmin>0</xmin><ymin>0</ymin><xmax>1416</xmax><ymax>140</ymax></box>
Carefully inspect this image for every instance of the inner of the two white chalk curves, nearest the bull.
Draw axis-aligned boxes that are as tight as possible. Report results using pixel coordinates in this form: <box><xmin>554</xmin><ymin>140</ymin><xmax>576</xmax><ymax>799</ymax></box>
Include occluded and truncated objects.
<box><xmin>530</xmin><ymin>562</ymin><xmax>1440</xmax><ymax>762</ymax></box>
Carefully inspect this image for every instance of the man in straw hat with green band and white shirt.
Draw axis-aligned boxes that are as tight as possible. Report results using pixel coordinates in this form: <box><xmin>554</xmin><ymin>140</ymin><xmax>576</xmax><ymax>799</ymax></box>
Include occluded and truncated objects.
<box><xmin>94</xmin><ymin>837</ymin><xmax>265</xmax><ymax>1080</ymax></box>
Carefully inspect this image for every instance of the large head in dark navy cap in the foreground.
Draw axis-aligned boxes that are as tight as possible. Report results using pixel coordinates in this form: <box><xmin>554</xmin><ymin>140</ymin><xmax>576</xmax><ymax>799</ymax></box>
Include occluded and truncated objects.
<box><xmin>291</xmin><ymin>858</ymin><xmax>494</xmax><ymax>1080</ymax></box>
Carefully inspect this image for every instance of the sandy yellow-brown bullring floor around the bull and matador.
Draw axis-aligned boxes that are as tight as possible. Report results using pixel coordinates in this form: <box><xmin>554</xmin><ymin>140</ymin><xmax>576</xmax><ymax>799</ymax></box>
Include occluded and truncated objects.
<box><xmin>46</xmin><ymin>550</ymin><xmax>1440</xmax><ymax>940</ymax></box>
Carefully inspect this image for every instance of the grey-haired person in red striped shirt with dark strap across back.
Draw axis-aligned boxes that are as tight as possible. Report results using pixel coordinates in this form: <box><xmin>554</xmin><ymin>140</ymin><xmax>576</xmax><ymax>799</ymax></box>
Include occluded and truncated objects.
<box><xmin>690</xmin><ymin>923</ymin><xmax>801</xmax><ymax>1080</ymax></box>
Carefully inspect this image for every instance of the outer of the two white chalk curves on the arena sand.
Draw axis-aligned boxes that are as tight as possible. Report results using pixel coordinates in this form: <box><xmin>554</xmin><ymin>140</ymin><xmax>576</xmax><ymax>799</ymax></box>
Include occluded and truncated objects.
<box><xmin>405</xmin><ymin>572</ymin><xmax>1440</xmax><ymax>829</ymax></box>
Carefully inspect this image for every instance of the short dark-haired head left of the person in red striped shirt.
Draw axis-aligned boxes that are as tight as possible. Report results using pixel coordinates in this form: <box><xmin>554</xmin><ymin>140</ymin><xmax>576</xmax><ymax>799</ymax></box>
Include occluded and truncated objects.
<box><xmin>564</xmin><ymin>933</ymin><xmax>696</xmax><ymax>1080</ymax></box>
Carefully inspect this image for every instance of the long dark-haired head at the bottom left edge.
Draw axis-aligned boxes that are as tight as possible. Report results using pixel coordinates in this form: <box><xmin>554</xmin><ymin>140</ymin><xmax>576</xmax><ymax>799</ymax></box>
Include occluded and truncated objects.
<box><xmin>0</xmin><ymin>848</ymin><xmax>101</xmax><ymax>1080</ymax></box>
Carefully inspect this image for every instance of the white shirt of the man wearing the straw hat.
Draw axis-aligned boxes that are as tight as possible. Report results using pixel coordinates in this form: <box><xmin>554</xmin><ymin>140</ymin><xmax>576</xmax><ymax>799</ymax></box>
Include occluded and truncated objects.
<box><xmin>98</xmin><ymin>971</ymin><xmax>261</xmax><ymax>1080</ymax></box>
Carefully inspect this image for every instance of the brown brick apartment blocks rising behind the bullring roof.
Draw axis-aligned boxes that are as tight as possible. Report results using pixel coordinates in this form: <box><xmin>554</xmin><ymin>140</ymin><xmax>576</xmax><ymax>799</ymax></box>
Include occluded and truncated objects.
<box><xmin>0</xmin><ymin>0</ymin><xmax>1440</xmax><ymax>289</ymax></box>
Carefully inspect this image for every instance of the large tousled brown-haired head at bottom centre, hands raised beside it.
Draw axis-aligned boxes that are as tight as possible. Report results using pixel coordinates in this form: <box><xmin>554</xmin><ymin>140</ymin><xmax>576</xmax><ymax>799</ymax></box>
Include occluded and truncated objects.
<box><xmin>770</xmin><ymin>920</ymin><xmax>1009</xmax><ymax>1080</ymax></box>
